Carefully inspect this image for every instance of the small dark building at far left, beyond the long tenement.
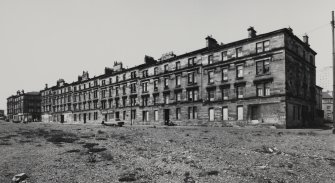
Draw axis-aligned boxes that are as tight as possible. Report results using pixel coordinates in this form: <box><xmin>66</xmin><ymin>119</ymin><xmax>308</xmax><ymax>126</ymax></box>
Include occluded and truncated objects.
<box><xmin>7</xmin><ymin>90</ymin><xmax>41</xmax><ymax>122</ymax></box>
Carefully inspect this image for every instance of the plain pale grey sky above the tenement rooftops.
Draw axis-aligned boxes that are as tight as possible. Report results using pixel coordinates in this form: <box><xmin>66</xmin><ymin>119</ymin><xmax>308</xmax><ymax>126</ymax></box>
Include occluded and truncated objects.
<box><xmin>0</xmin><ymin>0</ymin><xmax>335</xmax><ymax>113</ymax></box>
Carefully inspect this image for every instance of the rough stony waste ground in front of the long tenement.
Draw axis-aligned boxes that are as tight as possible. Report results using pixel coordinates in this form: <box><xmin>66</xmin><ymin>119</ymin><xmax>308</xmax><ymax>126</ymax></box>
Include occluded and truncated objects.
<box><xmin>0</xmin><ymin>122</ymin><xmax>335</xmax><ymax>183</ymax></box>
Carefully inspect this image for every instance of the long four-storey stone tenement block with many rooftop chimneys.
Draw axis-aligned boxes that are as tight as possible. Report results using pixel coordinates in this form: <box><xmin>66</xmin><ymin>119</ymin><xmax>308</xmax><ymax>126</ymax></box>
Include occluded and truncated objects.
<box><xmin>41</xmin><ymin>27</ymin><xmax>316</xmax><ymax>128</ymax></box>
